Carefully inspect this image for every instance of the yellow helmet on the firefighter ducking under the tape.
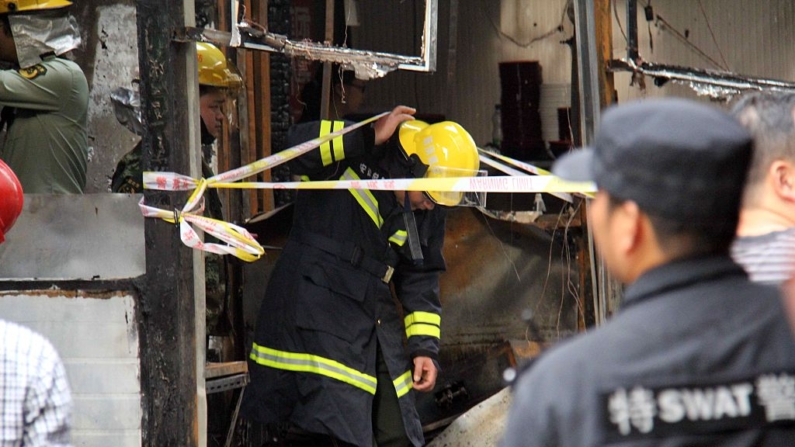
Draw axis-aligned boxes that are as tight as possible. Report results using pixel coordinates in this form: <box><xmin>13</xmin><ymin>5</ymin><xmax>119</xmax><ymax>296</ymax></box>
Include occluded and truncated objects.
<box><xmin>398</xmin><ymin>120</ymin><xmax>480</xmax><ymax>206</ymax></box>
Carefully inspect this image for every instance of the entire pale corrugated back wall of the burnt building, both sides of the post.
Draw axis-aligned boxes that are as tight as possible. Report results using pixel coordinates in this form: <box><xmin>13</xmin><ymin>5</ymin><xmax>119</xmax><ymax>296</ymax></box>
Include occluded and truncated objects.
<box><xmin>350</xmin><ymin>0</ymin><xmax>795</xmax><ymax>144</ymax></box>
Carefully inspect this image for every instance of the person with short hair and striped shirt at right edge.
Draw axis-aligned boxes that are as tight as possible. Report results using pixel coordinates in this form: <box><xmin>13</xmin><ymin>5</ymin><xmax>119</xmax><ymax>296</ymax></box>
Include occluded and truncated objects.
<box><xmin>732</xmin><ymin>92</ymin><xmax>795</xmax><ymax>285</ymax></box>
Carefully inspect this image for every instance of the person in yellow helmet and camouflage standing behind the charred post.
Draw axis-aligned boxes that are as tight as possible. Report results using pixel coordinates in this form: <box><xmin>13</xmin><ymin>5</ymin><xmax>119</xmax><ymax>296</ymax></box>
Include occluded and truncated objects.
<box><xmin>111</xmin><ymin>42</ymin><xmax>243</xmax><ymax>338</ymax></box>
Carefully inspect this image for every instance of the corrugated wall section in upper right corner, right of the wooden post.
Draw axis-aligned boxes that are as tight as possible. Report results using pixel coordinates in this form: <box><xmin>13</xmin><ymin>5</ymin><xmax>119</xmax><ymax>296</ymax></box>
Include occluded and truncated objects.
<box><xmin>613</xmin><ymin>0</ymin><xmax>795</xmax><ymax>100</ymax></box>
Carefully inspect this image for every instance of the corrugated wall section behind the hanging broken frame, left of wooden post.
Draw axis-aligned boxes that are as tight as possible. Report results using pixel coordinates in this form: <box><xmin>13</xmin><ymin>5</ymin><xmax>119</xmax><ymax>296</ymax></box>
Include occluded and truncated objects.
<box><xmin>352</xmin><ymin>0</ymin><xmax>572</xmax><ymax>148</ymax></box>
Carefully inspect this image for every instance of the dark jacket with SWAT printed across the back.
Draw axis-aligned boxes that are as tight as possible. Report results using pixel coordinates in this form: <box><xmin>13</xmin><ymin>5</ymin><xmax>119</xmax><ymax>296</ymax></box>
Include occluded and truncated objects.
<box><xmin>502</xmin><ymin>256</ymin><xmax>795</xmax><ymax>447</ymax></box>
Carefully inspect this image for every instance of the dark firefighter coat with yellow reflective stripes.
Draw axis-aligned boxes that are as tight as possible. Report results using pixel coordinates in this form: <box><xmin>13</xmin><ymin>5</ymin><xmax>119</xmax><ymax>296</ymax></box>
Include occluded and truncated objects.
<box><xmin>242</xmin><ymin>122</ymin><xmax>445</xmax><ymax>447</ymax></box>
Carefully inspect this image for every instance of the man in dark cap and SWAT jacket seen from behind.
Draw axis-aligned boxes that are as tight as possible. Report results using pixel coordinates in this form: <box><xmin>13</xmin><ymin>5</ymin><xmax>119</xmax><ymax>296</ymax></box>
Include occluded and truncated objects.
<box><xmin>502</xmin><ymin>99</ymin><xmax>795</xmax><ymax>447</ymax></box>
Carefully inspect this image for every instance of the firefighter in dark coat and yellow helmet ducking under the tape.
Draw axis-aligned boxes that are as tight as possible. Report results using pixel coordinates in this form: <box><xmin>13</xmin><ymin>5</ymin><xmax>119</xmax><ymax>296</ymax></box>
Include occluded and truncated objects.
<box><xmin>242</xmin><ymin>106</ymin><xmax>479</xmax><ymax>447</ymax></box>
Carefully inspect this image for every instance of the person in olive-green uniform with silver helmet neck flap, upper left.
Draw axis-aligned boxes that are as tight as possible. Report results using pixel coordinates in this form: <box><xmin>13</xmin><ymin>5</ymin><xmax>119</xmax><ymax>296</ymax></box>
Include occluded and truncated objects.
<box><xmin>0</xmin><ymin>0</ymin><xmax>89</xmax><ymax>194</ymax></box>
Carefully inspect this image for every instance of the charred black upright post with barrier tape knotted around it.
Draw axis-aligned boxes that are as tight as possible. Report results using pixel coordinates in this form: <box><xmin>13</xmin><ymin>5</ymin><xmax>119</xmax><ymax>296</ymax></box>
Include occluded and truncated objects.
<box><xmin>136</xmin><ymin>0</ymin><xmax>203</xmax><ymax>447</ymax></box>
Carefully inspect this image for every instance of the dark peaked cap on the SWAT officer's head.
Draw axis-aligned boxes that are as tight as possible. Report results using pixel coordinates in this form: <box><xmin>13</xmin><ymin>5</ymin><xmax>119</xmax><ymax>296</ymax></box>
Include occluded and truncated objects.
<box><xmin>552</xmin><ymin>98</ymin><xmax>753</xmax><ymax>223</ymax></box>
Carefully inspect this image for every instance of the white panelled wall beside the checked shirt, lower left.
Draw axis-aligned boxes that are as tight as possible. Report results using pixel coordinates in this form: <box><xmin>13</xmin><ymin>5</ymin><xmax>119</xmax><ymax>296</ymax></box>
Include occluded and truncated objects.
<box><xmin>0</xmin><ymin>290</ymin><xmax>142</xmax><ymax>447</ymax></box>
